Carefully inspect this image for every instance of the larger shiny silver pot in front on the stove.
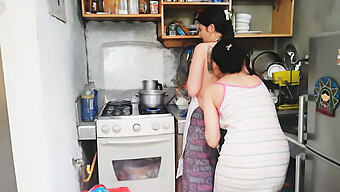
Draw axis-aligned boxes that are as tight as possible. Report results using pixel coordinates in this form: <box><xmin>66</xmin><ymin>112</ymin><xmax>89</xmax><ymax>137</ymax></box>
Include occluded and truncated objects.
<box><xmin>138</xmin><ymin>90</ymin><xmax>165</xmax><ymax>108</ymax></box>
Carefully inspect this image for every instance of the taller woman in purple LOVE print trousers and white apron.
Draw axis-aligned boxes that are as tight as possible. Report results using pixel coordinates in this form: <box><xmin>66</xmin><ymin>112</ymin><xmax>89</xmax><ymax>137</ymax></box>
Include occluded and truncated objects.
<box><xmin>177</xmin><ymin>7</ymin><xmax>234</xmax><ymax>192</ymax></box>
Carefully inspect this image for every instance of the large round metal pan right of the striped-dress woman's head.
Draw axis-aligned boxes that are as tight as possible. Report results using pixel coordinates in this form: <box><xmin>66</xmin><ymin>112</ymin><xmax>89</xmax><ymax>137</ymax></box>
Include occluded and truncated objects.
<box><xmin>252</xmin><ymin>51</ymin><xmax>281</xmax><ymax>78</ymax></box>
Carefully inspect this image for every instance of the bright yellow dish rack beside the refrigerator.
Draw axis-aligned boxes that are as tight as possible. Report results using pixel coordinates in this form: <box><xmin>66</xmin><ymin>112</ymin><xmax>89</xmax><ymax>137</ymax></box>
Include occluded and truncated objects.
<box><xmin>272</xmin><ymin>70</ymin><xmax>300</xmax><ymax>110</ymax></box>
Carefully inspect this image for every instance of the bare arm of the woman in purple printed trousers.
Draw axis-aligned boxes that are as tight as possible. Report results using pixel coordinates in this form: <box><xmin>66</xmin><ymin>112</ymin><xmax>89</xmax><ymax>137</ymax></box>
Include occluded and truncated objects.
<box><xmin>187</xmin><ymin>44</ymin><xmax>207</xmax><ymax>97</ymax></box>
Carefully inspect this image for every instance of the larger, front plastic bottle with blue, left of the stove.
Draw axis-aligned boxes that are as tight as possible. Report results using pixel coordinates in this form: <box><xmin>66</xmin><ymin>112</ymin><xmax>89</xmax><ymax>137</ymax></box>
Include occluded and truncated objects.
<box><xmin>81</xmin><ymin>85</ymin><xmax>95</xmax><ymax>122</ymax></box>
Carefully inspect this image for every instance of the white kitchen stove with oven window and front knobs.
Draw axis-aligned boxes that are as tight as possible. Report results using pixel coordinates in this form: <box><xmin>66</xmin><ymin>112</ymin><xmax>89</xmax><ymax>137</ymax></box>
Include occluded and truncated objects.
<box><xmin>96</xmin><ymin>100</ymin><xmax>175</xmax><ymax>192</ymax></box>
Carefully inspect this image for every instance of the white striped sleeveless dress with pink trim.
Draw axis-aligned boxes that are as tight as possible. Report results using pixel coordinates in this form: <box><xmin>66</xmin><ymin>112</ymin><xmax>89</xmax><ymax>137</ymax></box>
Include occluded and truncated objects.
<box><xmin>214</xmin><ymin>81</ymin><xmax>289</xmax><ymax>192</ymax></box>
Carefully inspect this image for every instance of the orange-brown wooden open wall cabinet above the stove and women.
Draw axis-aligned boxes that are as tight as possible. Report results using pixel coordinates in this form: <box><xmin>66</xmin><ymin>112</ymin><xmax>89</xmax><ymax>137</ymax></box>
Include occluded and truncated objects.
<box><xmin>81</xmin><ymin>0</ymin><xmax>294</xmax><ymax>47</ymax></box>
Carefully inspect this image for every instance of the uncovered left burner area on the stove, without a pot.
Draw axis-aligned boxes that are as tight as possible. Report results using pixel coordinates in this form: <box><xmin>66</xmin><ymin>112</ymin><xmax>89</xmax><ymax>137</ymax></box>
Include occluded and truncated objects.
<box><xmin>101</xmin><ymin>100</ymin><xmax>132</xmax><ymax>117</ymax></box>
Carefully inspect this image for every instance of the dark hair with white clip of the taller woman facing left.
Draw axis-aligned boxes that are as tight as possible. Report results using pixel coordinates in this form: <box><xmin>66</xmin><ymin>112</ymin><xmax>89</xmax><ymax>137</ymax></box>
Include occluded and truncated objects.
<box><xmin>197</xmin><ymin>7</ymin><xmax>234</xmax><ymax>39</ymax></box>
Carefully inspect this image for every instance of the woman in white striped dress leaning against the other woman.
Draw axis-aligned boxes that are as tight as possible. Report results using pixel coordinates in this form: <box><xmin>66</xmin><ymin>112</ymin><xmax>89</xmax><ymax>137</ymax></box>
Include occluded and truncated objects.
<box><xmin>203</xmin><ymin>38</ymin><xmax>290</xmax><ymax>192</ymax></box>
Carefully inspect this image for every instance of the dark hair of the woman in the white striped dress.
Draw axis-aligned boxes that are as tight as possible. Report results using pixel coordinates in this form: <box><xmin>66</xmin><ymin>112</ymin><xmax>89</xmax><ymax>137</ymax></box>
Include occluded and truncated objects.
<box><xmin>211</xmin><ymin>39</ymin><xmax>253</xmax><ymax>75</ymax></box>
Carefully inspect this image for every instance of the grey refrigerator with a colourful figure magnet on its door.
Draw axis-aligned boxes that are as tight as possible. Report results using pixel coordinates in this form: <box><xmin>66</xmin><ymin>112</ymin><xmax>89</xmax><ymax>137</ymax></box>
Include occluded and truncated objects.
<box><xmin>295</xmin><ymin>31</ymin><xmax>340</xmax><ymax>192</ymax></box>
